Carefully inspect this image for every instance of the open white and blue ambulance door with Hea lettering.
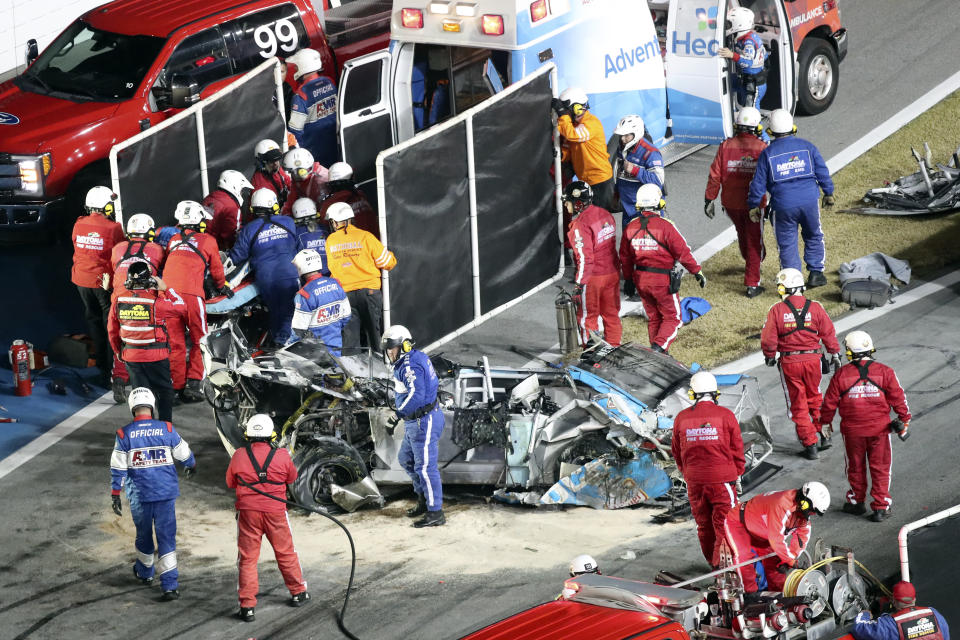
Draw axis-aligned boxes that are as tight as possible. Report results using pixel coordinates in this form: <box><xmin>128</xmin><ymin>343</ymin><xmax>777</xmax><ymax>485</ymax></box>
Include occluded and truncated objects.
<box><xmin>666</xmin><ymin>0</ymin><xmax>733</xmax><ymax>144</ymax></box>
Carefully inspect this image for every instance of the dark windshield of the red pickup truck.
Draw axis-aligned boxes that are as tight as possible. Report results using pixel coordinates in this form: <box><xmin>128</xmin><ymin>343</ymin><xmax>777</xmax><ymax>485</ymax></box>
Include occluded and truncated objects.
<box><xmin>18</xmin><ymin>20</ymin><xmax>165</xmax><ymax>102</ymax></box>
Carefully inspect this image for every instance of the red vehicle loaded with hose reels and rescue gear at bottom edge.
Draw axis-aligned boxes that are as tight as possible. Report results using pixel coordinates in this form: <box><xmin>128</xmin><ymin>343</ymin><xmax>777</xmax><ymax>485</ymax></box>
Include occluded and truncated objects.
<box><xmin>462</xmin><ymin>541</ymin><xmax>889</xmax><ymax>640</ymax></box>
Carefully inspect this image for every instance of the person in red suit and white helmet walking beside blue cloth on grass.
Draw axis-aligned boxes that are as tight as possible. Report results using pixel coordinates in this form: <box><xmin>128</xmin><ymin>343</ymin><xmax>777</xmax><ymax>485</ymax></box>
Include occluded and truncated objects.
<box><xmin>620</xmin><ymin>184</ymin><xmax>707</xmax><ymax>353</ymax></box>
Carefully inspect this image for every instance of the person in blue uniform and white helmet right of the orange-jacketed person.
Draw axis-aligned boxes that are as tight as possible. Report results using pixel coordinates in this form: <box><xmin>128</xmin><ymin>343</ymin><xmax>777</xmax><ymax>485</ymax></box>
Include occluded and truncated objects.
<box><xmin>613</xmin><ymin>115</ymin><xmax>664</xmax><ymax>222</ymax></box>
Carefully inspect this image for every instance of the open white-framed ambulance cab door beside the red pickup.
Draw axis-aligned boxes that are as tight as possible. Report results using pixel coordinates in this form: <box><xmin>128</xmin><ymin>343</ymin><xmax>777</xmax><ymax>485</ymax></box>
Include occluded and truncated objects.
<box><xmin>337</xmin><ymin>51</ymin><xmax>396</xmax><ymax>185</ymax></box>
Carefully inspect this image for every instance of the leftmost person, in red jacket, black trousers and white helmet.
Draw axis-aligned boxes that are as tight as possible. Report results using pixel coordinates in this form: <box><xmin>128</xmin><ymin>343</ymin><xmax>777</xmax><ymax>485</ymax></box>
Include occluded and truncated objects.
<box><xmin>70</xmin><ymin>187</ymin><xmax>123</xmax><ymax>388</ymax></box>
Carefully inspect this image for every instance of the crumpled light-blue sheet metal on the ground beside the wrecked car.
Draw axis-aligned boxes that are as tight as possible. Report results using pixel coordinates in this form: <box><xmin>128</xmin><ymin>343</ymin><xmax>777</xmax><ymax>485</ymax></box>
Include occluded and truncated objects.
<box><xmin>540</xmin><ymin>450</ymin><xmax>671</xmax><ymax>509</ymax></box>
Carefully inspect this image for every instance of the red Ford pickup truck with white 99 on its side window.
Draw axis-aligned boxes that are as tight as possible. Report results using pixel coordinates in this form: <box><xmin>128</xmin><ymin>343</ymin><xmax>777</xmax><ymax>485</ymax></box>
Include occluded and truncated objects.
<box><xmin>0</xmin><ymin>0</ymin><xmax>389</xmax><ymax>241</ymax></box>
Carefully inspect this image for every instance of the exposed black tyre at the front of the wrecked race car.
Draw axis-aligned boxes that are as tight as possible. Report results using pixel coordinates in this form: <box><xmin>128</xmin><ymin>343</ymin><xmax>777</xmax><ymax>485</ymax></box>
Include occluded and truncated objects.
<box><xmin>290</xmin><ymin>437</ymin><xmax>367</xmax><ymax>509</ymax></box>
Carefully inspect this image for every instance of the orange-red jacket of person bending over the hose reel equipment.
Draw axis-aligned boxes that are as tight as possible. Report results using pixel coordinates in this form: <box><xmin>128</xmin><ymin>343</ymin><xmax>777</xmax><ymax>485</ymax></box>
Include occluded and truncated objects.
<box><xmin>738</xmin><ymin>489</ymin><xmax>811</xmax><ymax>567</ymax></box>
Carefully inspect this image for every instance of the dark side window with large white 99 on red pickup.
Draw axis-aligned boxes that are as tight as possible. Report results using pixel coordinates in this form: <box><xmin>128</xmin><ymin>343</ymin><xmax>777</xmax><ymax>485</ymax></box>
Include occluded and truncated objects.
<box><xmin>222</xmin><ymin>3</ymin><xmax>310</xmax><ymax>72</ymax></box>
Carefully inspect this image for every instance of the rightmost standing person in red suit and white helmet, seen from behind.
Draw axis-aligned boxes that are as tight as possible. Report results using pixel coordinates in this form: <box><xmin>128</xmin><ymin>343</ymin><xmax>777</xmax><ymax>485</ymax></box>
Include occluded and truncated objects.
<box><xmin>820</xmin><ymin>331</ymin><xmax>910</xmax><ymax>522</ymax></box>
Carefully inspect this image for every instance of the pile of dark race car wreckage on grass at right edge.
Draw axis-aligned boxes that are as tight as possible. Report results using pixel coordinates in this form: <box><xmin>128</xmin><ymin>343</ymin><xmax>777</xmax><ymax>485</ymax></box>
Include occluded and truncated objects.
<box><xmin>843</xmin><ymin>143</ymin><xmax>960</xmax><ymax>216</ymax></box>
